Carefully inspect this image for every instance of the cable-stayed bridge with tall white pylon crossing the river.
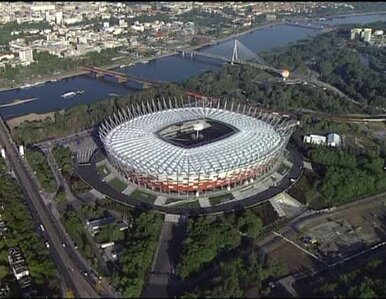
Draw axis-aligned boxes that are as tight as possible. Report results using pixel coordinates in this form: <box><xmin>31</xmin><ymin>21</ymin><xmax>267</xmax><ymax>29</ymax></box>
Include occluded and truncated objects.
<box><xmin>177</xmin><ymin>39</ymin><xmax>282</xmax><ymax>74</ymax></box>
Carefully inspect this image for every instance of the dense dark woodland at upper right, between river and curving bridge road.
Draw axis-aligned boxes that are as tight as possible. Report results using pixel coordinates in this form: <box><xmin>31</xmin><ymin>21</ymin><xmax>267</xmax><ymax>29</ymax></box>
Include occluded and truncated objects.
<box><xmin>265</xmin><ymin>22</ymin><xmax>386</xmax><ymax>112</ymax></box>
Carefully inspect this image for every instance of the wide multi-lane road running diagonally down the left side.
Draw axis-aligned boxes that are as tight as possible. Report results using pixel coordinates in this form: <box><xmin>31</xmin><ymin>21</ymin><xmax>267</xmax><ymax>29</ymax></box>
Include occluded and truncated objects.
<box><xmin>0</xmin><ymin>119</ymin><xmax>100</xmax><ymax>298</ymax></box>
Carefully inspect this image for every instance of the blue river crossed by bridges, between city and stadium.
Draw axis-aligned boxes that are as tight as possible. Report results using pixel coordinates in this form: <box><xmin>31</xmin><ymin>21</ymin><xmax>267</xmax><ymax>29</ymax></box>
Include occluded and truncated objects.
<box><xmin>0</xmin><ymin>14</ymin><xmax>386</xmax><ymax>119</ymax></box>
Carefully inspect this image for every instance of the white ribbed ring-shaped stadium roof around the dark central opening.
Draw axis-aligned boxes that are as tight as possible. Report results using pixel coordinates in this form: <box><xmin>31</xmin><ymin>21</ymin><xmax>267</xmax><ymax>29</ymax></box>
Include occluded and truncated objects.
<box><xmin>103</xmin><ymin>107</ymin><xmax>285</xmax><ymax>174</ymax></box>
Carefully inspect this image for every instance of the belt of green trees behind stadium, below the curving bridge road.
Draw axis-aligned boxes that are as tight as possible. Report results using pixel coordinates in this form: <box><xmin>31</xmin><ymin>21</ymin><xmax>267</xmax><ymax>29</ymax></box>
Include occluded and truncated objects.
<box><xmin>184</xmin><ymin>65</ymin><xmax>356</xmax><ymax>113</ymax></box>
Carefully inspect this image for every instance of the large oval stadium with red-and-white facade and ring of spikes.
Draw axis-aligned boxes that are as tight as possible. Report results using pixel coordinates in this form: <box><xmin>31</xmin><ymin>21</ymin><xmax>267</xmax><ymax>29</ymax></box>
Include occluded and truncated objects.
<box><xmin>99</xmin><ymin>98</ymin><xmax>296</xmax><ymax>196</ymax></box>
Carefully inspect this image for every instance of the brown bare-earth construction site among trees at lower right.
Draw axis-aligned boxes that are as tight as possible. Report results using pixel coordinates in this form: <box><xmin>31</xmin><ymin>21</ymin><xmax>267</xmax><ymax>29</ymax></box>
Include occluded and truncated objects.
<box><xmin>259</xmin><ymin>194</ymin><xmax>386</xmax><ymax>293</ymax></box>
